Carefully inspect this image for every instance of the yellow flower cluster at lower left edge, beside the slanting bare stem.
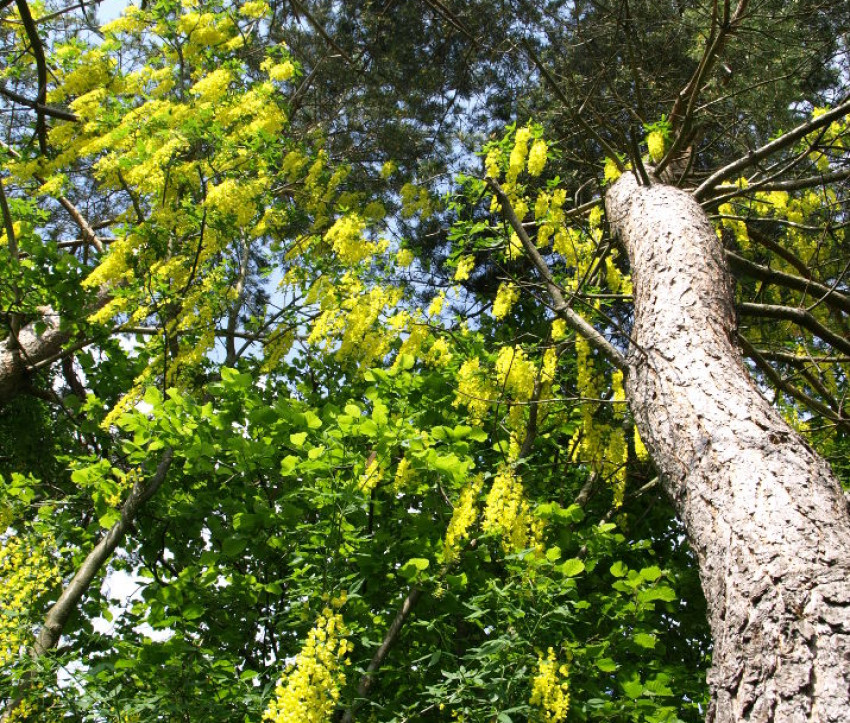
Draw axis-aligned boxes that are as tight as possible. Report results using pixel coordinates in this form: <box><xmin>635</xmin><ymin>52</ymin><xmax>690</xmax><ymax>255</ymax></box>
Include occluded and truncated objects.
<box><xmin>0</xmin><ymin>533</ymin><xmax>61</xmax><ymax>667</ymax></box>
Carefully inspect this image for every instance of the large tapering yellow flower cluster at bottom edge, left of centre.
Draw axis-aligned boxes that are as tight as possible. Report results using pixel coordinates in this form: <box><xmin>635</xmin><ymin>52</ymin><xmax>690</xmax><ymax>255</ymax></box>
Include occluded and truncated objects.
<box><xmin>263</xmin><ymin>608</ymin><xmax>353</xmax><ymax>723</ymax></box>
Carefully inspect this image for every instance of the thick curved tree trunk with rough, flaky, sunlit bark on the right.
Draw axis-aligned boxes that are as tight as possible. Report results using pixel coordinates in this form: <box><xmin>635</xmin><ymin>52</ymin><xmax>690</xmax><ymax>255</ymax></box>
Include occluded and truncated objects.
<box><xmin>606</xmin><ymin>173</ymin><xmax>850</xmax><ymax>723</ymax></box>
